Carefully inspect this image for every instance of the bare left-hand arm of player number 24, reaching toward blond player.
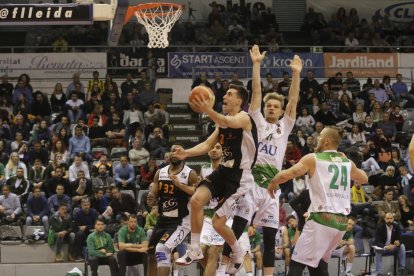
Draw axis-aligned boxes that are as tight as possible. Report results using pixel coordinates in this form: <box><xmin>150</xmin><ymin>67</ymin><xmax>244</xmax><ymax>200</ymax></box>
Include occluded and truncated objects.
<box><xmin>267</xmin><ymin>154</ymin><xmax>315</xmax><ymax>198</ymax></box>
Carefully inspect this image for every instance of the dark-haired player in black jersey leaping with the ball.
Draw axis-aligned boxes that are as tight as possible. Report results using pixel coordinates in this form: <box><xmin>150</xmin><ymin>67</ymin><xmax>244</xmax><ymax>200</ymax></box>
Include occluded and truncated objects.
<box><xmin>175</xmin><ymin>85</ymin><xmax>257</xmax><ymax>272</ymax></box>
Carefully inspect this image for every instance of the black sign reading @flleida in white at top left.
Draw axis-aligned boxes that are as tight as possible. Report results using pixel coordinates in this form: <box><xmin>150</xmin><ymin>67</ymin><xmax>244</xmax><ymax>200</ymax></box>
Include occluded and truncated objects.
<box><xmin>0</xmin><ymin>4</ymin><xmax>93</xmax><ymax>25</ymax></box>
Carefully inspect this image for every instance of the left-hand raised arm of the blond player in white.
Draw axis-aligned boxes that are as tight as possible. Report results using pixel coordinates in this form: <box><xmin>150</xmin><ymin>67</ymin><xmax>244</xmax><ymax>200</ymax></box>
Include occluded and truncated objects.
<box><xmin>249</xmin><ymin>45</ymin><xmax>266</xmax><ymax>112</ymax></box>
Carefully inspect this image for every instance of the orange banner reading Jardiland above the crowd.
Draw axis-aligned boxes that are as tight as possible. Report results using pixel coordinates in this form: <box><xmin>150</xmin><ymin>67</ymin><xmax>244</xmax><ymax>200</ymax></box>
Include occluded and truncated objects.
<box><xmin>323</xmin><ymin>53</ymin><xmax>399</xmax><ymax>78</ymax></box>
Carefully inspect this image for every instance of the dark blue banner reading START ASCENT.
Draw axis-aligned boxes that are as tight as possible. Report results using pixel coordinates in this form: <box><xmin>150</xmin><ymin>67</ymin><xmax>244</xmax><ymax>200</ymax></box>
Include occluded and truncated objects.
<box><xmin>168</xmin><ymin>52</ymin><xmax>247</xmax><ymax>79</ymax></box>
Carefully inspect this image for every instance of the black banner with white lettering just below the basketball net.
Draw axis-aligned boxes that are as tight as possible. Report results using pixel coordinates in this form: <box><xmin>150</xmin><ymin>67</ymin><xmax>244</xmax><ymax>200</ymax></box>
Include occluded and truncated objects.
<box><xmin>107</xmin><ymin>48</ymin><xmax>167</xmax><ymax>78</ymax></box>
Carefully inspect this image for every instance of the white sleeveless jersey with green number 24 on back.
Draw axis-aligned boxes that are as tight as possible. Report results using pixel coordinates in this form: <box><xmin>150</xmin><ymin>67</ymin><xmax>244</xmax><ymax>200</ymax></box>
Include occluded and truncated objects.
<box><xmin>308</xmin><ymin>151</ymin><xmax>352</xmax><ymax>215</ymax></box>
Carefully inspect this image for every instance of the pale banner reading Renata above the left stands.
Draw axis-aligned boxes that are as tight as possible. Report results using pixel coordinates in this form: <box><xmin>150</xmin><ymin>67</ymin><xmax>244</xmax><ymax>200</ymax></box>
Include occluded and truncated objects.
<box><xmin>0</xmin><ymin>53</ymin><xmax>107</xmax><ymax>79</ymax></box>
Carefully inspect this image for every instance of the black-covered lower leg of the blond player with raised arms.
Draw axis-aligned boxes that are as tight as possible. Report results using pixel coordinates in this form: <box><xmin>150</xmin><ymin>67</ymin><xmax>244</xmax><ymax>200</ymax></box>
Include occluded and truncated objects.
<box><xmin>263</xmin><ymin>227</ymin><xmax>277</xmax><ymax>276</ymax></box>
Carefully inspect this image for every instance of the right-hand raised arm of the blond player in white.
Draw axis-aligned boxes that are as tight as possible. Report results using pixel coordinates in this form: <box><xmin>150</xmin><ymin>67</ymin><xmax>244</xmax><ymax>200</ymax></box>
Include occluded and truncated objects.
<box><xmin>285</xmin><ymin>55</ymin><xmax>302</xmax><ymax>119</ymax></box>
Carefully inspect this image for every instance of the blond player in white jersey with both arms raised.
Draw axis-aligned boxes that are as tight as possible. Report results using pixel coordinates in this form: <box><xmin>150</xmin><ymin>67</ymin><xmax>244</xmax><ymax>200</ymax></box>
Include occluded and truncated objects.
<box><xmin>223</xmin><ymin>45</ymin><xmax>302</xmax><ymax>276</ymax></box>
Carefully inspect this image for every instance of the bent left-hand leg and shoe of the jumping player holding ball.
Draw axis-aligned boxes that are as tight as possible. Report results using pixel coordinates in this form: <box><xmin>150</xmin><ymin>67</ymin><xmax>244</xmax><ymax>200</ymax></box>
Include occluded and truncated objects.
<box><xmin>176</xmin><ymin>185</ymin><xmax>211</xmax><ymax>265</ymax></box>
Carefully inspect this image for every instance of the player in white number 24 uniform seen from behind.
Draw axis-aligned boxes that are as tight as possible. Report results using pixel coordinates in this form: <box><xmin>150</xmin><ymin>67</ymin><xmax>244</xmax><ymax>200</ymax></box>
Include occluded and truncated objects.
<box><xmin>267</xmin><ymin>126</ymin><xmax>368</xmax><ymax>276</ymax></box>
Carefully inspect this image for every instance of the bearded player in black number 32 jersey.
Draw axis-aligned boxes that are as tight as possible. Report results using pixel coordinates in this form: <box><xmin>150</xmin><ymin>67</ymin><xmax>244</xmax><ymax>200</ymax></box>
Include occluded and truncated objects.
<box><xmin>147</xmin><ymin>144</ymin><xmax>198</xmax><ymax>276</ymax></box>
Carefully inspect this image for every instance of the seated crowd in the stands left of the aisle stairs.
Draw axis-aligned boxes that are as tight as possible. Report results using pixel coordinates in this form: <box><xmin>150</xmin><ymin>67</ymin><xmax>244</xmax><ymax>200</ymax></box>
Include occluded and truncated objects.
<box><xmin>0</xmin><ymin>71</ymin><xmax>169</xmax><ymax>261</ymax></box>
